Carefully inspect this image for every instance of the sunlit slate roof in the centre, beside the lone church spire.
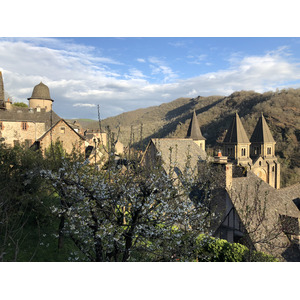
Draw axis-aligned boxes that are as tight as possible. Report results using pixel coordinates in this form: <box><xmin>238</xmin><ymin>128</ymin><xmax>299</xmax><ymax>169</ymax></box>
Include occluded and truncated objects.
<box><xmin>149</xmin><ymin>138</ymin><xmax>207</xmax><ymax>172</ymax></box>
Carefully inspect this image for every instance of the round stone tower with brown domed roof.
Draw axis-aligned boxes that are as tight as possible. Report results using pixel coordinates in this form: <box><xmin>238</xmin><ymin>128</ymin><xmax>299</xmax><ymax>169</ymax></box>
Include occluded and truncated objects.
<box><xmin>28</xmin><ymin>82</ymin><xmax>54</xmax><ymax>112</ymax></box>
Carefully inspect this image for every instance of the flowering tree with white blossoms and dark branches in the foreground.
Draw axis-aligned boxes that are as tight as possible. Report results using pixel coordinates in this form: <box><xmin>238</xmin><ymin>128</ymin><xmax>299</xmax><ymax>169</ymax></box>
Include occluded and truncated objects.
<box><xmin>42</xmin><ymin>151</ymin><xmax>217</xmax><ymax>261</ymax></box>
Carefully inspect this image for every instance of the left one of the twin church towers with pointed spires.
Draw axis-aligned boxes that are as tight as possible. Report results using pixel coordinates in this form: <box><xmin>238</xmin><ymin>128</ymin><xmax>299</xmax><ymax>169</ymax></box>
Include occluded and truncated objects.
<box><xmin>223</xmin><ymin>113</ymin><xmax>251</xmax><ymax>166</ymax></box>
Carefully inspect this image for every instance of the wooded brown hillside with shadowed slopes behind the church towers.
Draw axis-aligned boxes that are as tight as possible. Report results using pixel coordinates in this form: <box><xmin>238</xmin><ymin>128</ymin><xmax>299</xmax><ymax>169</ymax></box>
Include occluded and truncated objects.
<box><xmin>75</xmin><ymin>89</ymin><xmax>300</xmax><ymax>186</ymax></box>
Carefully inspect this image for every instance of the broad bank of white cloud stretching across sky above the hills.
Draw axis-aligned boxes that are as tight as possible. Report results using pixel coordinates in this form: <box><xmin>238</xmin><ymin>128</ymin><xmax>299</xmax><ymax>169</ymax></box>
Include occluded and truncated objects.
<box><xmin>0</xmin><ymin>38</ymin><xmax>300</xmax><ymax>119</ymax></box>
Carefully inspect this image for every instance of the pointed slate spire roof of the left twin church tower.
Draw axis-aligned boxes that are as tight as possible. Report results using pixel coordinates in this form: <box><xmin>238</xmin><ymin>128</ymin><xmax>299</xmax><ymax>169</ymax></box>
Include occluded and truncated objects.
<box><xmin>223</xmin><ymin>113</ymin><xmax>250</xmax><ymax>144</ymax></box>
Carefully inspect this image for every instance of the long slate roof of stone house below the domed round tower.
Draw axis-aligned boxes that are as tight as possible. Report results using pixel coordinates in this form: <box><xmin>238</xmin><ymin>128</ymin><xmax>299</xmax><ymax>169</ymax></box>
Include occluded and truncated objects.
<box><xmin>0</xmin><ymin>106</ymin><xmax>60</xmax><ymax>130</ymax></box>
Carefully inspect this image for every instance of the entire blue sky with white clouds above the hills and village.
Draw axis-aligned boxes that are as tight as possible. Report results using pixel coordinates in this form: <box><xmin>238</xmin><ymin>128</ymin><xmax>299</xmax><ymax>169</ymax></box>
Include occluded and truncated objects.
<box><xmin>0</xmin><ymin>37</ymin><xmax>300</xmax><ymax>119</ymax></box>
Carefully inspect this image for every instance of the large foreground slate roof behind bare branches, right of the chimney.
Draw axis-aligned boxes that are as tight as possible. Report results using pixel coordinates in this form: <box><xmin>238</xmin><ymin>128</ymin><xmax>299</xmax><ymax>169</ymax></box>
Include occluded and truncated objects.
<box><xmin>229</xmin><ymin>171</ymin><xmax>300</xmax><ymax>261</ymax></box>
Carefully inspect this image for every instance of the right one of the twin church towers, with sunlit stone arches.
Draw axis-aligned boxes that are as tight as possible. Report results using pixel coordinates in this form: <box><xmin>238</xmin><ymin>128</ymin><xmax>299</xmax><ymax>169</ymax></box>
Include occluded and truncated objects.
<box><xmin>250</xmin><ymin>114</ymin><xmax>280</xmax><ymax>189</ymax></box>
